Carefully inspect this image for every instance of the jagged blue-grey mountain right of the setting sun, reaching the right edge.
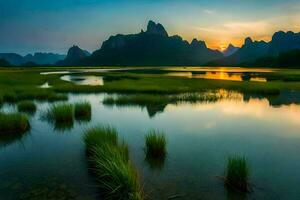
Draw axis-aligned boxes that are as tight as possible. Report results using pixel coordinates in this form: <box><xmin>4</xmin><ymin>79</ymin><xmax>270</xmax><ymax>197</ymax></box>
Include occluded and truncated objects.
<box><xmin>208</xmin><ymin>31</ymin><xmax>300</xmax><ymax>66</ymax></box>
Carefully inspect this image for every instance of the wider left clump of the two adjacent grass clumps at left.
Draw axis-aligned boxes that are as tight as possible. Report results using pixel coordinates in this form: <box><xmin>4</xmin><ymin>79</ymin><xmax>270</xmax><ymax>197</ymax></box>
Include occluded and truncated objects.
<box><xmin>45</xmin><ymin>103</ymin><xmax>74</xmax><ymax>130</ymax></box>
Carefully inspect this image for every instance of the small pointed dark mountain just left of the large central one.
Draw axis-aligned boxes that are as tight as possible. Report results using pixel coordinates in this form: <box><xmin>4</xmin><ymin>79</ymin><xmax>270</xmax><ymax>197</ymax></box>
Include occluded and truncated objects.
<box><xmin>57</xmin><ymin>45</ymin><xmax>91</xmax><ymax>66</ymax></box>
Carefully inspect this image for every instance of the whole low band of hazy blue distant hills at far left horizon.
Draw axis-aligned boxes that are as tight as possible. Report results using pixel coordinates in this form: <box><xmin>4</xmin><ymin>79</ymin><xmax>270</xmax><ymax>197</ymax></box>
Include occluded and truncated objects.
<box><xmin>0</xmin><ymin>53</ymin><xmax>65</xmax><ymax>65</ymax></box>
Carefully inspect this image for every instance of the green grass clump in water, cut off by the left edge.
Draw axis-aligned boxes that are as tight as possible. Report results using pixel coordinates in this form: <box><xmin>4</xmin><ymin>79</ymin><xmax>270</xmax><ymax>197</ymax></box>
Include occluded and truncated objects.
<box><xmin>0</xmin><ymin>113</ymin><xmax>30</xmax><ymax>135</ymax></box>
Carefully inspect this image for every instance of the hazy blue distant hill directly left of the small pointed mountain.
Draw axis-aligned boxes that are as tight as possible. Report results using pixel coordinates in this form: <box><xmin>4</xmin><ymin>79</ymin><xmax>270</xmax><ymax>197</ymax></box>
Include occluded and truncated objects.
<box><xmin>24</xmin><ymin>53</ymin><xmax>66</xmax><ymax>65</ymax></box>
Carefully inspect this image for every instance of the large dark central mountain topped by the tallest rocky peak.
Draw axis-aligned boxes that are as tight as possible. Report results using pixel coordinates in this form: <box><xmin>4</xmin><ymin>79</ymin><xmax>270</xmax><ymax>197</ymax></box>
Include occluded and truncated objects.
<box><xmin>78</xmin><ymin>21</ymin><xmax>223</xmax><ymax>66</ymax></box>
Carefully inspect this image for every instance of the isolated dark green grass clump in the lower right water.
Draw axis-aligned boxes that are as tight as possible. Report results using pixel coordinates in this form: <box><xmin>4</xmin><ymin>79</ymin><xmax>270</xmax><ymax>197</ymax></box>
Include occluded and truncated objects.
<box><xmin>225</xmin><ymin>156</ymin><xmax>250</xmax><ymax>192</ymax></box>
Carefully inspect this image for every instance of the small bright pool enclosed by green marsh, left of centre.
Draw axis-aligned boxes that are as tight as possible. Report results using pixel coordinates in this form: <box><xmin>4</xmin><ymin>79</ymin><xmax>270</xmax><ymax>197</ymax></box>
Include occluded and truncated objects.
<box><xmin>61</xmin><ymin>75</ymin><xmax>104</xmax><ymax>86</ymax></box>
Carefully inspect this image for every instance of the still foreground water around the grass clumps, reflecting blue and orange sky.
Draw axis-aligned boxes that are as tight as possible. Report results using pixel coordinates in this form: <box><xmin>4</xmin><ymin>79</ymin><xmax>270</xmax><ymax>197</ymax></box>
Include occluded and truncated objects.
<box><xmin>0</xmin><ymin>93</ymin><xmax>300</xmax><ymax>200</ymax></box>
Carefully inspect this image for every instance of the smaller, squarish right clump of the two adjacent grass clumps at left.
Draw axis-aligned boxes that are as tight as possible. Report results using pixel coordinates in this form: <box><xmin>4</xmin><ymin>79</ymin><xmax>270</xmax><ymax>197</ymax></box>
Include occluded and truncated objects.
<box><xmin>74</xmin><ymin>102</ymin><xmax>92</xmax><ymax>121</ymax></box>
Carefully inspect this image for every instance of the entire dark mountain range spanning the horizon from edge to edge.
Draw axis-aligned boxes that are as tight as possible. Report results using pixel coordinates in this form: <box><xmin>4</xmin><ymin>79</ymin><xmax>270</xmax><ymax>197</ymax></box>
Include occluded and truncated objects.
<box><xmin>0</xmin><ymin>20</ymin><xmax>300</xmax><ymax>67</ymax></box>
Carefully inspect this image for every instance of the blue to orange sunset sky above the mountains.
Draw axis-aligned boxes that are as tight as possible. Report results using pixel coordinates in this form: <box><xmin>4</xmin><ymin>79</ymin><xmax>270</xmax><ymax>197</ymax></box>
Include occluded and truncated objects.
<box><xmin>0</xmin><ymin>0</ymin><xmax>300</xmax><ymax>55</ymax></box>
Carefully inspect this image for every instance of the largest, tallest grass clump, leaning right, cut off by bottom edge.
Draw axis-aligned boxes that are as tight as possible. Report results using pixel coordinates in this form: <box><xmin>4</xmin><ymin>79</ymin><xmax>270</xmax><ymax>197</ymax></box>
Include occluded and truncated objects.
<box><xmin>84</xmin><ymin>126</ymin><xmax>143</xmax><ymax>200</ymax></box>
